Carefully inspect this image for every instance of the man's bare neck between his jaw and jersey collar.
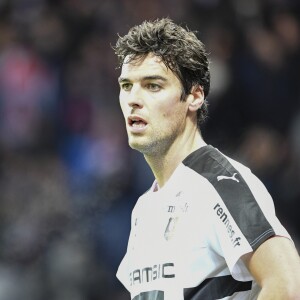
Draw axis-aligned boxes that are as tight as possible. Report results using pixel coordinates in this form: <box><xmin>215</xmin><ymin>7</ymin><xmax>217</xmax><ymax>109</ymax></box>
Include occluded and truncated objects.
<box><xmin>145</xmin><ymin>130</ymin><xmax>206</xmax><ymax>187</ymax></box>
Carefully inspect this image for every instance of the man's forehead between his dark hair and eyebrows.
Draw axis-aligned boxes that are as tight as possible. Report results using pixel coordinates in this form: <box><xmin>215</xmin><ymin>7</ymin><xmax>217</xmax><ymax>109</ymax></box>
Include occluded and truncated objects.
<box><xmin>121</xmin><ymin>53</ymin><xmax>176</xmax><ymax>79</ymax></box>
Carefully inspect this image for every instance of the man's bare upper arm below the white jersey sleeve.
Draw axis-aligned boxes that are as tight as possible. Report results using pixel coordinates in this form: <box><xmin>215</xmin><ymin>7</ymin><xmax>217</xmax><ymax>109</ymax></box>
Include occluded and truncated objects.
<box><xmin>244</xmin><ymin>236</ymin><xmax>300</xmax><ymax>300</ymax></box>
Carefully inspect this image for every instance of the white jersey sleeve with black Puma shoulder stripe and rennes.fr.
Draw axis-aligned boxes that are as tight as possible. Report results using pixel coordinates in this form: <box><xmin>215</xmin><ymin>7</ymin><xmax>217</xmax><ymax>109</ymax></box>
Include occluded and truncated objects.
<box><xmin>183</xmin><ymin>145</ymin><xmax>290</xmax><ymax>281</ymax></box>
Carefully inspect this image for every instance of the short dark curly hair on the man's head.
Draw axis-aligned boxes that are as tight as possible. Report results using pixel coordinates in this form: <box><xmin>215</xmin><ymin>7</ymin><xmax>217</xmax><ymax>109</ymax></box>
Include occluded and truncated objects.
<box><xmin>113</xmin><ymin>18</ymin><xmax>210</xmax><ymax>126</ymax></box>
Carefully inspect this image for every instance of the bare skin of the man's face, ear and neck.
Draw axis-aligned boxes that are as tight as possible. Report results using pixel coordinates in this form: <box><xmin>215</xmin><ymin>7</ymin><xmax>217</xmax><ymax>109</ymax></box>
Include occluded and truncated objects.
<box><xmin>119</xmin><ymin>54</ymin><xmax>205</xmax><ymax>187</ymax></box>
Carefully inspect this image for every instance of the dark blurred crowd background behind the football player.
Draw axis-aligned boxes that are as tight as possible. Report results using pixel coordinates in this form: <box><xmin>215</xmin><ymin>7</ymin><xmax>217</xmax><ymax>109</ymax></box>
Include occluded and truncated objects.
<box><xmin>0</xmin><ymin>0</ymin><xmax>300</xmax><ymax>300</ymax></box>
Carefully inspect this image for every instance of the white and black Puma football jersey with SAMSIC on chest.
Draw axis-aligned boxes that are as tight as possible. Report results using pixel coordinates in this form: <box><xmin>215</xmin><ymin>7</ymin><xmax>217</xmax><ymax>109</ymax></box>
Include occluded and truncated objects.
<box><xmin>117</xmin><ymin>145</ymin><xmax>290</xmax><ymax>300</ymax></box>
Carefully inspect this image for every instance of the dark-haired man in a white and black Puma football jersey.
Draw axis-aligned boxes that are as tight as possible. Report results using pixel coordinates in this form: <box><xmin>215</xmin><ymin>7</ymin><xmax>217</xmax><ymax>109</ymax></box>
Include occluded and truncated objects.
<box><xmin>115</xmin><ymin>18</ymin><xmax>300</xmax><ymax>300</ymax></box>
